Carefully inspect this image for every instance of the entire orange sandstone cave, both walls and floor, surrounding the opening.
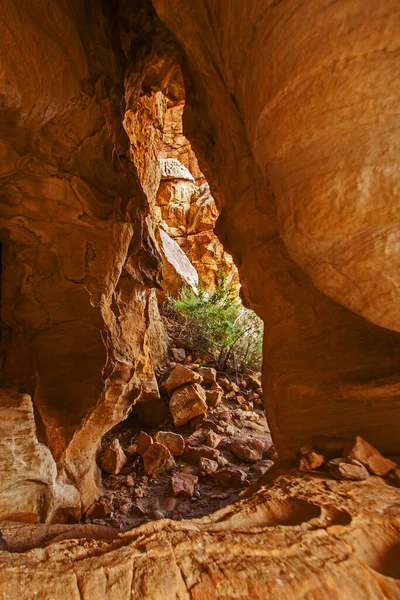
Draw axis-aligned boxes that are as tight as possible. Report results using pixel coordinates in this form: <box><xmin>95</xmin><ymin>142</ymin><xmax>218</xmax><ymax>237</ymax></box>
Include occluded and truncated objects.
<box><xmin>0</xmin><ymin>0</ymin><xmax>400</xmax><ymax>600</ymax></box>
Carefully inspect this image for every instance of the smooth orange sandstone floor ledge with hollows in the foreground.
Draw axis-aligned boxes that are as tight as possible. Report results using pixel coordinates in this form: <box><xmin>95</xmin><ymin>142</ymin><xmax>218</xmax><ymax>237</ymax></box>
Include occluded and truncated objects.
<box><xmin>0</xmin><ymin>469</ymin><xmax>400</xmax><ymax>600</ymax></box>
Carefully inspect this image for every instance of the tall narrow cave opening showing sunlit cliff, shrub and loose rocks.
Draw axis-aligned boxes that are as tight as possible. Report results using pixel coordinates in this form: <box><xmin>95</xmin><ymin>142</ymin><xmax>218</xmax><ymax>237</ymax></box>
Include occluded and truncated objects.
<box><xmin>89</xmin><ymin>91</ymin><xmax>276</xmax><ymax>531</ymax></box>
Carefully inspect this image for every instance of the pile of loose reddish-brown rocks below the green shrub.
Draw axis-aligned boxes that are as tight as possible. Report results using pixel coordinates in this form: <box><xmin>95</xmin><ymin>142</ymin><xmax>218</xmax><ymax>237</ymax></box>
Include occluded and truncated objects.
<box><xmin>85</xmin><ymin>347</ymin><xmax>276</xmax><ymax>530</ymax></box>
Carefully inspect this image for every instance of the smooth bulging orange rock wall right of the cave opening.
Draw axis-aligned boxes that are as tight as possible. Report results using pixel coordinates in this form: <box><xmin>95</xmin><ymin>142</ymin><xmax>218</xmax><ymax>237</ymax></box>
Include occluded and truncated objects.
<box><xmin>153</xmin><ymin>0</ymin><xmax>400</xmax><ymax>454</ymax></box>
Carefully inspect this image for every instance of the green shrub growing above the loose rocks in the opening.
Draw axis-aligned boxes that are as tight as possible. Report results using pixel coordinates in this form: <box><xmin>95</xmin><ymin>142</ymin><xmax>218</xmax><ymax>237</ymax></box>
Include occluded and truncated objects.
<box><xmin>164</xmin><ymin>275</ymin><xmax>263</xmax><ymax>371</ymax></box>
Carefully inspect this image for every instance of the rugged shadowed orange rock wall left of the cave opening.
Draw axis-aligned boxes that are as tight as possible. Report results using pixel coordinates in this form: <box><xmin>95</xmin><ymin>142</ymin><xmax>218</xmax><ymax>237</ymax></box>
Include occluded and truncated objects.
<box><xmin>0</xmin><ymin>0</ymin><xmax>165</xmax><ymax>519</ymax></box>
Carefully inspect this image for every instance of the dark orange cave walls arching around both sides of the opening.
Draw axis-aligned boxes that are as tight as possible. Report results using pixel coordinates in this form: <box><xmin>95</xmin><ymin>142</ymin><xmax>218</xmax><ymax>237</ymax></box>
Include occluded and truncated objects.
<box><xmin>0</xmin><ymin>0</ymin><xmax>400</xmax><ymax>518</ymax></box>
